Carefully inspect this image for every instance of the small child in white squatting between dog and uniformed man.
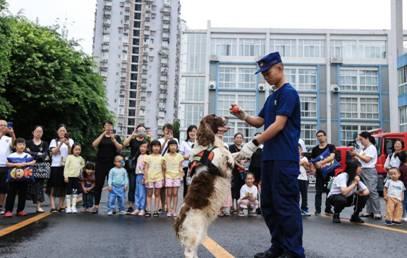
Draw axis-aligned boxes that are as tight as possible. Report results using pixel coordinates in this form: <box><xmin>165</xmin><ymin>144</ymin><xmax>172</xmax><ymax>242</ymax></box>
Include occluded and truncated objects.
<box><xmin>238</xmin><ymin>173</ymin><xmax>259</xmax><ymax>216</ymax></box>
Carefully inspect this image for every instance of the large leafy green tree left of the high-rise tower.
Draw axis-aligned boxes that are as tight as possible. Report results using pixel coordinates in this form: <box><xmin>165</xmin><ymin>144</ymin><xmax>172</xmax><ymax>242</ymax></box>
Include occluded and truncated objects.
<box><xmin>1</xmin><ymin>17</ymin><xmax>111</xmax><ymax>158</ymax></box>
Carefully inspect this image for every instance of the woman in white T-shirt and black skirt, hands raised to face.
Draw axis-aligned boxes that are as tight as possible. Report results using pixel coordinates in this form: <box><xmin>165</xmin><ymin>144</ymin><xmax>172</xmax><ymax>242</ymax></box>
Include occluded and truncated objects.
<box><xmin>47</xmin><ymin>124</ymin><xmax>74</xmax><ymax>212</ymax></box>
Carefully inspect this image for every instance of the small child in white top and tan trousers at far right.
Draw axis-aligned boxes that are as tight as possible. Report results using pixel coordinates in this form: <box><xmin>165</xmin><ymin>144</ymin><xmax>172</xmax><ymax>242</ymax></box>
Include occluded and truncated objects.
<box><xmin>383</xmin><ymin>168</ymin><xmax>406</xmax><ymax>225</ymax></box>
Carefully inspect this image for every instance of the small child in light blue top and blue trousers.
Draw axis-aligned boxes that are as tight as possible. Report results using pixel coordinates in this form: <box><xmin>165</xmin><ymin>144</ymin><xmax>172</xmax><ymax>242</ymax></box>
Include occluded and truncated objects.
<box><xmin>107</xmin><ymin>155</ymin><xmax>129</xmax><ymax>216</ymax></box>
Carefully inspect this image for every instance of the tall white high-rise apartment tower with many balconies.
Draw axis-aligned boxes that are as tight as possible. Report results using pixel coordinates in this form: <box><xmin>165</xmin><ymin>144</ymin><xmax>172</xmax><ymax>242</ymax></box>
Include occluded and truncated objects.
<box><xmin>93</xmin><ymin>0</ymin><xmax>181</xmax><ymax>135</ymax></box>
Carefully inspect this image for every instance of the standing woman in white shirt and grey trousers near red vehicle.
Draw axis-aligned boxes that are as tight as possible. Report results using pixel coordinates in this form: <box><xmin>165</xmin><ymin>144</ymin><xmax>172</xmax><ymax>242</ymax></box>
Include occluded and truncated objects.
<box><xmin>352</xmin><ymin>132</ymin><xmax>382</xmax><ymax>220</ymax></box>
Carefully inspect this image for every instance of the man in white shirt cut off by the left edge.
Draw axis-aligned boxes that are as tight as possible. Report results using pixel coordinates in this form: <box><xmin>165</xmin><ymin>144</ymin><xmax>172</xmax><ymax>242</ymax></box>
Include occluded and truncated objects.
<box><xmin>0</xmin><ymin>120</ymin><xmax>16</xmax><ymax>215</ymax></box>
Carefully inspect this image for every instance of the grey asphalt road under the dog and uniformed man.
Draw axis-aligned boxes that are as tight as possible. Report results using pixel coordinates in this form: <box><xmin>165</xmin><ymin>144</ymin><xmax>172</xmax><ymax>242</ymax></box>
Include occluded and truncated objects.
<box><xmin>0</xmin><ymin>187</ymin><xmax>407</xmax><ymax>258</ymax></box>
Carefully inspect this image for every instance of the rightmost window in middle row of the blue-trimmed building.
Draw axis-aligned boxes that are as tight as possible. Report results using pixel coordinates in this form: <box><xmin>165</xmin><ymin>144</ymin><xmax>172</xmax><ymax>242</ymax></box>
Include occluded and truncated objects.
<box><xmin>338</xmin><ymin>67</ymin><xmax>379</xmax><ymax>93</ymax></box>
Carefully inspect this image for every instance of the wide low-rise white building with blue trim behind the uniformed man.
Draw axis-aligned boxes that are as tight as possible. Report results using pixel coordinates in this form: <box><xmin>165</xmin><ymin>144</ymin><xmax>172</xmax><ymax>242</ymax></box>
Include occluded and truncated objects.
<box><xmin>179</xmin><ymin>24</ymin><xmax>397</xmax><ymax>146</ymax></box>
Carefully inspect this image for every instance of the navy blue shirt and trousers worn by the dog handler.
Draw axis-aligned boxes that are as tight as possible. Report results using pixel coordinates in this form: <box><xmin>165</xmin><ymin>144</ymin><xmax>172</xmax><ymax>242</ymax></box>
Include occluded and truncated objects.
<box><xmin>259</xmin><ymin>83</ymin><xmax>305</xmax><ymax>257</ymax></box>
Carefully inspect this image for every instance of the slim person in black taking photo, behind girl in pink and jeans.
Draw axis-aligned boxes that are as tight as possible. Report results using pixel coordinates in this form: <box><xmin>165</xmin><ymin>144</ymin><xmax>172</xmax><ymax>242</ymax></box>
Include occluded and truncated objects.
<box><xmin>123</xmin><ymin>124</ymin><xmax>151</xmax><ymax>213</ymax></box>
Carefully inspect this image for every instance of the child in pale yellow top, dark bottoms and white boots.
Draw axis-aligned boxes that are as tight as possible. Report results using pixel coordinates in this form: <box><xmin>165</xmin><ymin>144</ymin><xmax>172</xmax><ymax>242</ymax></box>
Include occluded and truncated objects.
<box><xmin>64</xmin><ymin>144</ymin><xmax>85</xmax><ymax>214</ymax></box>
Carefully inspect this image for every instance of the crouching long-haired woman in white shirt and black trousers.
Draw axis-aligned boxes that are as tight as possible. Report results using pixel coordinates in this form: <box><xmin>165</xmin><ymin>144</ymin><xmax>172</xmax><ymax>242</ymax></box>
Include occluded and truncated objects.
<box><xmin>328</xmin><ymin>160</ymin><xmax>369</xmax><ymax>223</ymax></box>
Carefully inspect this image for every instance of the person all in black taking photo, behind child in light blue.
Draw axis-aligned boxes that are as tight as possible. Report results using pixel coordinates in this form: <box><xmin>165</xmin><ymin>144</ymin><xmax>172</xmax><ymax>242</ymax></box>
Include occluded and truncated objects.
<box><xmin>92</xmin><ymin>121</ymin><xmax>123</xmax><ymax>214</ymax></box>
